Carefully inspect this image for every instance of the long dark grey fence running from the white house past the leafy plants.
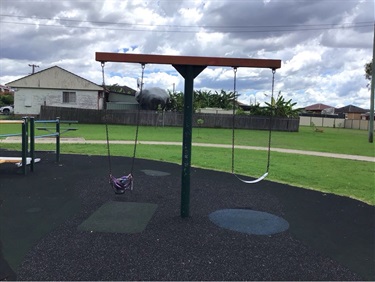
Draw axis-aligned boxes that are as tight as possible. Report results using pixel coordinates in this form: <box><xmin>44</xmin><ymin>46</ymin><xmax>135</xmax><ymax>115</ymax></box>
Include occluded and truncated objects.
<box><xmin>40</xmin><ymin>106</ymin><xmax>299</xmax><ymax>132</ymax></box>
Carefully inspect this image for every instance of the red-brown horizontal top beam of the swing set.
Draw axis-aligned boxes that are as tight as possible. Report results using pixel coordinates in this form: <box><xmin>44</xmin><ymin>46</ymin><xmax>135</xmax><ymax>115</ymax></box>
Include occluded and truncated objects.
<box><xmin>95</xmin><ymin>52</ymin><xmax>281</xmax><ymax>69</ymax></box>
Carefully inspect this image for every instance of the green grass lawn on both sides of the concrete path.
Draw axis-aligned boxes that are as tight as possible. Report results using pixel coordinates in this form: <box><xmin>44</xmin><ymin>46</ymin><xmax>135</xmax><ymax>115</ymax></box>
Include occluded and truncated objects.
<box><xmin>0</xmin><ymin>124</ymin><xmax>375</xmax><ymax>205</ymax></box>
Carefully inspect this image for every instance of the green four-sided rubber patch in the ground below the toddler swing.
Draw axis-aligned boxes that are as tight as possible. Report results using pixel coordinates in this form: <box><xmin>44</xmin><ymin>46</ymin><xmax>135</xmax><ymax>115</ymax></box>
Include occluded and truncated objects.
<box><xmin>78</xmin><ymin>201</ymin><xmax>158</xmax><ymax>233</ymax></box>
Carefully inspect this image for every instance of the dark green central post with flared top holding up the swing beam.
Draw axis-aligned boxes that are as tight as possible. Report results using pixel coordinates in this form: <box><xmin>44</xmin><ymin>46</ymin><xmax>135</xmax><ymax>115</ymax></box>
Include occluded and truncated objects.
<box><xmin>173</xmin><ymin>65</ymin><xmax>206</xmax><ymax>218</ymax></box>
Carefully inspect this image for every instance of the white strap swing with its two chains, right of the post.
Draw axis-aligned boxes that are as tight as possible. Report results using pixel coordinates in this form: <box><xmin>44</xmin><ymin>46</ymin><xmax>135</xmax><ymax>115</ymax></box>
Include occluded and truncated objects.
<box><xmin>232</xmin><ymin>67</ymin><xmax>276</xmax><ymax>184</ymax></box>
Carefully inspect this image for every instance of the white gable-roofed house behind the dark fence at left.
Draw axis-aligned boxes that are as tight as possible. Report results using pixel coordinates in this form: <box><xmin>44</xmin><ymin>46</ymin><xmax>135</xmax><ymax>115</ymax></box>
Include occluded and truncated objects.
<box><xmin>6</xmin><ymin>66</ymin><xmax>104</xmax><ymax>115</ymax></box>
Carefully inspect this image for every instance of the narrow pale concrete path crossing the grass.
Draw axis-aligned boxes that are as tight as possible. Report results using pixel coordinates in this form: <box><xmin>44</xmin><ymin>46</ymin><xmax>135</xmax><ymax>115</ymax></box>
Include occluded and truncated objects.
<box><xmin>0</xmin><ymin>137</ymin><xmax>375</xmax><ymax>162</ymax></box>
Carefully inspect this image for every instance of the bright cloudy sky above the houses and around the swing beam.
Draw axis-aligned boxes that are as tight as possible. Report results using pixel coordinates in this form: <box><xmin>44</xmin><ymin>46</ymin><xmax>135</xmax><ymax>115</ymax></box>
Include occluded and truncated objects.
<box><xmin>0</xmin><ymin>0</ymin><xmax>375</xmax><ymax>109</ymax></box>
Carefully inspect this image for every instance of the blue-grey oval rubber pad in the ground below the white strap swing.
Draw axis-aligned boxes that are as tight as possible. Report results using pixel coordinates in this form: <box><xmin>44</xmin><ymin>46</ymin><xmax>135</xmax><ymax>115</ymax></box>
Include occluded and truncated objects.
<box><xmin>209</xmin><ymin>209</ymin><xmax>289</xmax><ymax>235</ymax></box>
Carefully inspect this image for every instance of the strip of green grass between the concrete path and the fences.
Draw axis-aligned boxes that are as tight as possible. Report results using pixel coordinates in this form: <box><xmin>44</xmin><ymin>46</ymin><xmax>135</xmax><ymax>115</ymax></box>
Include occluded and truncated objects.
<box><xmin>0</xmin><ymin>124</ymin><xmax>375</xmax><ymax>156</ymax></box>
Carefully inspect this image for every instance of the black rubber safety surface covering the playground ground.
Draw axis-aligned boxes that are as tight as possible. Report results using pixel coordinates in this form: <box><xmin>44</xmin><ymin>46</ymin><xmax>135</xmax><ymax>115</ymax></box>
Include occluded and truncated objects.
<box><xmin>0</xmin><ymin>150</ymin><xmax>375</xmax><ymax>280</ymax></box>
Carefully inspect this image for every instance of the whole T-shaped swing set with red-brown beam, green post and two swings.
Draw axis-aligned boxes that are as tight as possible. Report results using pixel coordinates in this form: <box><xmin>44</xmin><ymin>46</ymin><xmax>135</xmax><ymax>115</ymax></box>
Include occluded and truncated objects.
<box><xmin>95</xmin><ymin>52</ymin><xmax>281</xmax><ymax>218</ymax></box>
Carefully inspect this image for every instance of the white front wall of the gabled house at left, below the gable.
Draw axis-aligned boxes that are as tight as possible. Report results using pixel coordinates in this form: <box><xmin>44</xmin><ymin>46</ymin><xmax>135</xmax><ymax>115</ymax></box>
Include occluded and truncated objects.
<box><xmin>14</xmin><ymin>88</ymin><xmax>102</xmax><ymax>115</ymax></box>
